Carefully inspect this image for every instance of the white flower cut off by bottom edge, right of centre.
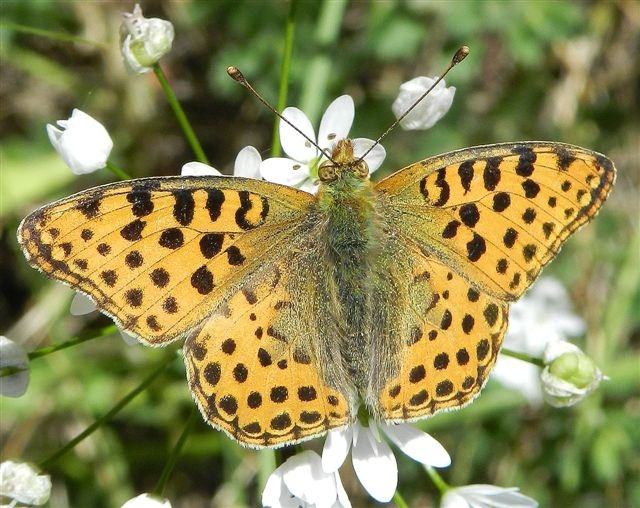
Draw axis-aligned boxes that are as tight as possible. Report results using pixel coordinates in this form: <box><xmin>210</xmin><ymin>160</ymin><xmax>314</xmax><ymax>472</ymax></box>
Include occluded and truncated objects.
<box><xmin>440</xmin><ymin>485</ymin><xmax>538</xmax><ymax>508</ymax></box>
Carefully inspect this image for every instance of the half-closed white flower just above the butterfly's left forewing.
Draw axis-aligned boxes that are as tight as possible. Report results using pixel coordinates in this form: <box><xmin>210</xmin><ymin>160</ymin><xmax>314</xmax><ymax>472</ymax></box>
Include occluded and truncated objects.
<box><xmin>47</xmin><ymin>109</ymin><xmax>113</xmax><ymax>175</ymax></box>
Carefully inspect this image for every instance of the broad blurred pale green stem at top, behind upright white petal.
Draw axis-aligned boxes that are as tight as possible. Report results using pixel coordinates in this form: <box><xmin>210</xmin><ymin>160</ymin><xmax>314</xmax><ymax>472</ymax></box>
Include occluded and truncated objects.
<box><xmin>300</xmin><ymin>0</ymin><xmax>347</xmax><ymax>123</ymax></box>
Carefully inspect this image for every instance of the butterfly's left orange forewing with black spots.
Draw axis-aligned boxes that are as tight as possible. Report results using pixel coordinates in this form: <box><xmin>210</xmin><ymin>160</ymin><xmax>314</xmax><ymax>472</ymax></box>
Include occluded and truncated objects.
<box><xmin>18</xmin><ymin>177</ymin><xmax>312</xmax><ymax>344</ymax></box>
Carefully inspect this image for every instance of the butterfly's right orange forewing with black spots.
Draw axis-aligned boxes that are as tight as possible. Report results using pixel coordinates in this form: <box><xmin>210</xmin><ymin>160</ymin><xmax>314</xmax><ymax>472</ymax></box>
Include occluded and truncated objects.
<box><xmin>376</xmin><ymin>142</ymin><xmax>615</xmax><ymax>300</ymax></box>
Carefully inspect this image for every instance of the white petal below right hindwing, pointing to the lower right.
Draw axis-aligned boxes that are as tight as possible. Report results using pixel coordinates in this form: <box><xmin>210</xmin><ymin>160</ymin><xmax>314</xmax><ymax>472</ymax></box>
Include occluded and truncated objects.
<box><xmin>380</xmin><ymin>423</ymin><xmax>451</xmax><ymax>467</ymax></box>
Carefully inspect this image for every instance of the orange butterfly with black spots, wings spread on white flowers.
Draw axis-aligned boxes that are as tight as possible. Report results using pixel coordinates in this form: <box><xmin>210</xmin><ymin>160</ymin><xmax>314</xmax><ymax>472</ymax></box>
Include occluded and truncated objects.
<box><xmin>18</xmin><ymin>139</ymin><xmax>615</xmax><ymax>448</ymax></box>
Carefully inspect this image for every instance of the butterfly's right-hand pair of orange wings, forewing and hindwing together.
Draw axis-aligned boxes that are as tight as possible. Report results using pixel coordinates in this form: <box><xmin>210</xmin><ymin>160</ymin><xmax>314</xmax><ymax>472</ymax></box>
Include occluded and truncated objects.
<box><xmin>376</xmin><ymin>142</ymin><xmax>615</xmax><ymax>421</ymax></box>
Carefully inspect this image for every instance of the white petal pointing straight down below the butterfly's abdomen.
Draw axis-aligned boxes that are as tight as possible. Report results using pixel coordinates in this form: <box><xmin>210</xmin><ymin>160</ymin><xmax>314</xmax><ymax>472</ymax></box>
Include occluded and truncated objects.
<box><xmin>351</xmin><ymin>426</ymin><xmax>398</xmax><ymax>503</ymax></box>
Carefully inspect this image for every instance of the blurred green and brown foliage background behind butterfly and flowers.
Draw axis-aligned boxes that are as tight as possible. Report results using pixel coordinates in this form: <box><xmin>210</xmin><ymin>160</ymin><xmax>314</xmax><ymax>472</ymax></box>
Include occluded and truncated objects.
<box><xmin>0</xmin><ymin>0</ymin><xmax>640</xmax><ymax>508</ymax></box>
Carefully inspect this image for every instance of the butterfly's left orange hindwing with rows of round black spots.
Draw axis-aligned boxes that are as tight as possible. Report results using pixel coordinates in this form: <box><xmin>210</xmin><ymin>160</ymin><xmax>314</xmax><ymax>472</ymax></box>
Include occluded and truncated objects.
<box><xmin>184</xmin><ymin>259</ymin><xmax>351</xmax><ymax>447</ymax></box>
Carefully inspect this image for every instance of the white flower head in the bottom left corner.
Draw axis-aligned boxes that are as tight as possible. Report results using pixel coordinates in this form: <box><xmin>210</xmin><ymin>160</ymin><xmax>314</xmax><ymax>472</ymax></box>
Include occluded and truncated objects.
<box><xmin>0</xmin><ymin>460</ymin><xmax>51</xmax><ymax>506</ymax></box>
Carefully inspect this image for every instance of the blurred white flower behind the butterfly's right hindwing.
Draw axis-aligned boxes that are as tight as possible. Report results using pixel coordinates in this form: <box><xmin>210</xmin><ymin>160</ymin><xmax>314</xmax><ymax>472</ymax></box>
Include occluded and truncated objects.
<box><xmin>492</xmin><ymin>277</ymin><xmax>586</xmax><ymax>405</ymax></box>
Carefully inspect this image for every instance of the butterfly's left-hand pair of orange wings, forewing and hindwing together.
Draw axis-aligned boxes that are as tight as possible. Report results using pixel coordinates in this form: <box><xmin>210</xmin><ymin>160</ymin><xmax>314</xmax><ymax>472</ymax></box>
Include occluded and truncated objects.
<box><xmin>18</xmin><ymin>177</ymin><xmax>350</xmax><ymax>447</ymax></box>
